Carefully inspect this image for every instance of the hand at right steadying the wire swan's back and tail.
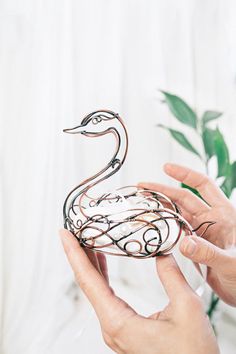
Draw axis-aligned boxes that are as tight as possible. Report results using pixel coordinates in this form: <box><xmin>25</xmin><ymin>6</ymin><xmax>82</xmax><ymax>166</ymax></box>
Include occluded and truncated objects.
<box><xmin>139</xmin><ymin>164</ymin><xmax>236</xmax><ymax>306</ymax></box>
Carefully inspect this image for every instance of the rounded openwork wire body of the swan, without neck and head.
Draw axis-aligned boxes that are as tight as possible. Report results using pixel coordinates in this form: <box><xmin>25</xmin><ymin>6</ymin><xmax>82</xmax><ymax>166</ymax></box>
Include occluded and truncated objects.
<box><xmin>64</xmin><ymin>186</ymin><xmax>212</xmax><ymax>258</ymax></box>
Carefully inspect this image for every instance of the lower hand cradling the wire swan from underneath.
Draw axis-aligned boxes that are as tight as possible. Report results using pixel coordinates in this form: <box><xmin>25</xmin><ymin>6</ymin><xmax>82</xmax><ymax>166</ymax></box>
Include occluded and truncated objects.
<box><xmin>61</xmin><ymin>230</ymin><xmax>219</xmax><ymax>354</ymax></box>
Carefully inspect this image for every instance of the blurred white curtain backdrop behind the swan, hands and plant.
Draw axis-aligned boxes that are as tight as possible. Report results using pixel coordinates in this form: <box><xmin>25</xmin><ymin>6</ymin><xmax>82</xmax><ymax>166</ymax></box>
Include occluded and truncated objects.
<box><xmin>0</xmin><ymin>0</ymin><xmax>236</xmax><ymax>354</ymax></box>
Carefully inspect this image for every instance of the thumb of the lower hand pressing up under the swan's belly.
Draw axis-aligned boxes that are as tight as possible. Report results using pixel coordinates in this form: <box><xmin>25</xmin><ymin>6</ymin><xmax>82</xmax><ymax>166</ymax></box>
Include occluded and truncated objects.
<box><xmin>156</xmin><ymin>256</ymin><xmax>193</xmax><ymax>303</ymax></box>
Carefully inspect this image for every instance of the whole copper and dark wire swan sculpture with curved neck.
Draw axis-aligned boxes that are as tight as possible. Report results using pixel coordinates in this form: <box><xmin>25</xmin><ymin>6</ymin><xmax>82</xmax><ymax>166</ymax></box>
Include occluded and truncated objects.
<box><xmin>63</xmin><ymin>110</ymin><xmax>214</xmax><ymax>258</ymax></box>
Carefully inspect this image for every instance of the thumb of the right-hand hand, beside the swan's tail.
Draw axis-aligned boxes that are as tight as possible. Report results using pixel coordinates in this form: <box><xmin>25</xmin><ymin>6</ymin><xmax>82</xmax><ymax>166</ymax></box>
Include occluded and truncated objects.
<box><xmin>180</xmin><ymin>236</ymin><xmax>229</xmax><ymax>269</ymax></box>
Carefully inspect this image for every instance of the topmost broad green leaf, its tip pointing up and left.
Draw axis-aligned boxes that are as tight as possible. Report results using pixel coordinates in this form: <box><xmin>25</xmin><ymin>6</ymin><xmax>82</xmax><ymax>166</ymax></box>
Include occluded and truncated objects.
<box><xmin>161</xmin><ymin>91</ymin><xmax>197</xmax><ymax>129</ymax></box>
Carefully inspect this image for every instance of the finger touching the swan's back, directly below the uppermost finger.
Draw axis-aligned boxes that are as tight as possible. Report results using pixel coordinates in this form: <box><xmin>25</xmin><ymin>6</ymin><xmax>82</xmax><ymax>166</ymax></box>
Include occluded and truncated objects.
<box><xmin>139</xmin><ymin>183</ymin><xmax>210</xmax><ymax>216</ymax></box>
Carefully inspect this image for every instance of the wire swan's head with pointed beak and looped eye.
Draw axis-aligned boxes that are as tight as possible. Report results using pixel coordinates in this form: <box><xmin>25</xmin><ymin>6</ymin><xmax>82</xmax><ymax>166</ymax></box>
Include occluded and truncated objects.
<box><xmin>63</xmin><ymin>110</ymin><xmax>121</xmax><ymax>137</ymax></box>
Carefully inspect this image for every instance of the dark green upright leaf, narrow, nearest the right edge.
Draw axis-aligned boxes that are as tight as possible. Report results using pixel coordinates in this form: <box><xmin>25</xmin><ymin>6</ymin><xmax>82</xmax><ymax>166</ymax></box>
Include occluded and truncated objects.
<box><xmin>214</xmin><ymin>128</ymin><xmax>230</xmax><ymax>177</ymax></box>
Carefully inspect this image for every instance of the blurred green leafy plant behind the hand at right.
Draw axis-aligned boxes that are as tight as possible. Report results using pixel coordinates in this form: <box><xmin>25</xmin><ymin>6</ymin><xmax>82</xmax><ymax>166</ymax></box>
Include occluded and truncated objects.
<box><xmin>158</xmin><ymin>91</ymin><xmax>236</xmax><ymax>330</ymax></box>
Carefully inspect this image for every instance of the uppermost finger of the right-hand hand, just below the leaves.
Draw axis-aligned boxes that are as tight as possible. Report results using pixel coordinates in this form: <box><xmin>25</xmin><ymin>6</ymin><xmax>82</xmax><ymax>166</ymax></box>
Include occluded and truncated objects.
<box><xmin>164</xmin><ymin>163</ymin><xmax>228</xmax><ymax>206</ymax></box>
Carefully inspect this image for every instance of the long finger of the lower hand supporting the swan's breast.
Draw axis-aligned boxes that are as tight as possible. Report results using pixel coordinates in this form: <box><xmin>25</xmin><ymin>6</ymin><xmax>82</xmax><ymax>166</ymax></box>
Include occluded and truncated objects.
<box><xmin>60</xmin><ymin>230</ymin><xmax>131</xmax><ymax>323</ymax></box>
